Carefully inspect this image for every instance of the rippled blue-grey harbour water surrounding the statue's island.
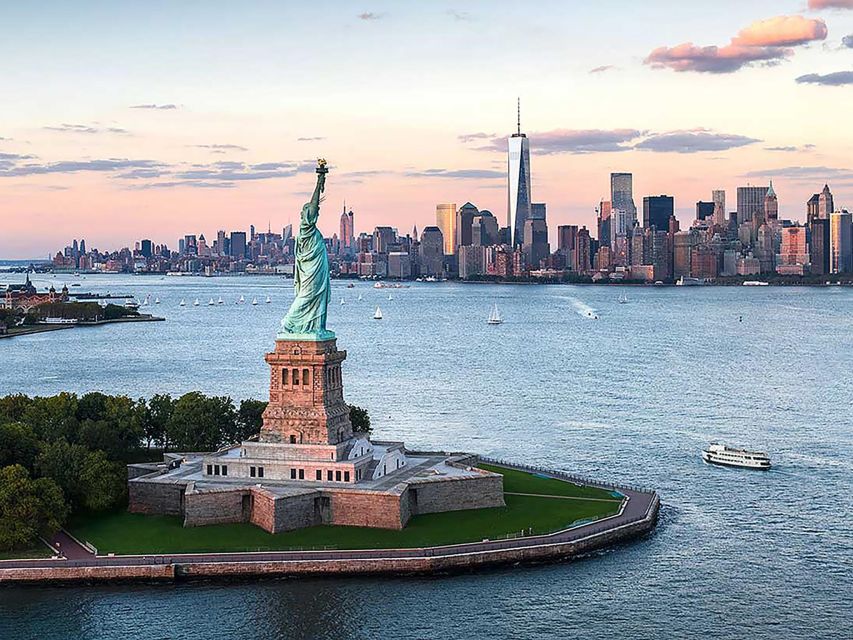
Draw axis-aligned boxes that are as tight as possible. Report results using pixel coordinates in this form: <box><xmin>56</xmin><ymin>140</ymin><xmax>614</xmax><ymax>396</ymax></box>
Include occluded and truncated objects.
<box><xmin>0</xmin><ymin>276</ymin><xmax>853</xmax><ymax>639</ymax></box>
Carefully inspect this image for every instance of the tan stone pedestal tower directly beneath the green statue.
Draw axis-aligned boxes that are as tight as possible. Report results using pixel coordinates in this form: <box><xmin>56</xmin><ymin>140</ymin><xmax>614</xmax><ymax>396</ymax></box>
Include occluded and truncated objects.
<box><xmin>259</xmin><ymin>339</ymin><xmax>352</xmax><ymax>445</ymax></box>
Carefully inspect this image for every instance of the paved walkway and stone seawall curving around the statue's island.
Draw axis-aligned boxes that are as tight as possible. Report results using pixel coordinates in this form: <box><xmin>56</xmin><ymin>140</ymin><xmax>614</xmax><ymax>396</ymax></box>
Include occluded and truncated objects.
<box><xmin>0</xmin><ymin>458</ymin><xmax>660</xmax><ymax>585</ymax></box>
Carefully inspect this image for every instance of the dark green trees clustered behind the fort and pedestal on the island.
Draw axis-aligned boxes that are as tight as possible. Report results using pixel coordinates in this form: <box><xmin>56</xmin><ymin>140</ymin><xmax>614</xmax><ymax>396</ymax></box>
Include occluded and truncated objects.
<box><xmin>0</xmin><ymin>391</ymin><xmax>370</xmax><ymax>550</ymax></box>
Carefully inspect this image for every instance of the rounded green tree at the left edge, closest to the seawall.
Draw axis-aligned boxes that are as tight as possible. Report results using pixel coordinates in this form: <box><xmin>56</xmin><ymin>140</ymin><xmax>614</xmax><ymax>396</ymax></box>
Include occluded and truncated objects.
<box><xmin>0</xmin><ymin>465</ymin><xmax>68</xmax><ymax>550</ymax></box>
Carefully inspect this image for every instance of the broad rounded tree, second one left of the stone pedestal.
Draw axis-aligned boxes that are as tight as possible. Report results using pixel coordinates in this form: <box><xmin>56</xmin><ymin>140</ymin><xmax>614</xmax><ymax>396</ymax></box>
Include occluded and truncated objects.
<box><xmin>166</xmin><ymin>391</ymin><xmax>237</xmax><ymax>451</ymax></box>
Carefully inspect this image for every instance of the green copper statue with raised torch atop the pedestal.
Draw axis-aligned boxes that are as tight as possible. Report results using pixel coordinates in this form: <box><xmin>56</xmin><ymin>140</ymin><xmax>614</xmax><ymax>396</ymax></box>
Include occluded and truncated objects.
<box><xmin>276</xmin><ymin>159</ymin><xmax>335</xmax><ymax>340</ymax></box>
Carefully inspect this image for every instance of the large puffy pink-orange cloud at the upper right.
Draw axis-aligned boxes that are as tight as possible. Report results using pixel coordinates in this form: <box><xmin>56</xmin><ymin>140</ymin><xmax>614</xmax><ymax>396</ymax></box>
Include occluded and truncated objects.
<box><xmin>645</xmin><ymin>16</ymin><xmax>827</xmax><ymax>73</ymax></box>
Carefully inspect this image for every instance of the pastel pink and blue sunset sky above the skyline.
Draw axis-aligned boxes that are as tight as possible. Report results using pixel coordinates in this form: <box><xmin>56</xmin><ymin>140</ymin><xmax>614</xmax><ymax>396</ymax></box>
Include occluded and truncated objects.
<box><xmin>0</xmin><ymin>0</ymin><xmax>853</xmax><ymax>259</ymax></box>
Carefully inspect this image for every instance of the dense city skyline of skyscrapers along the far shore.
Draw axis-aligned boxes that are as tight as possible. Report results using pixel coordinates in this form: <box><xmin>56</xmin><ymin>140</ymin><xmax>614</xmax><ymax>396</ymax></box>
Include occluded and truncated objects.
<box><xmin>48</xmin><ymin>132</ymin><xmax>853</xmax><ymax>283</ymax></box>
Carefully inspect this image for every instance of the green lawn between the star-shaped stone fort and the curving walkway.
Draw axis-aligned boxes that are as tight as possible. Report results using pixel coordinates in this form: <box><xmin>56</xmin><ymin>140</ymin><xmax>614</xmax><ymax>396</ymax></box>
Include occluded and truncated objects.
<box><xmin>70</xmin><ymin>465</ymin><xmax>621</xmax><ymax>554</ymax></box>
